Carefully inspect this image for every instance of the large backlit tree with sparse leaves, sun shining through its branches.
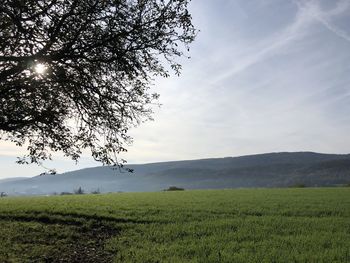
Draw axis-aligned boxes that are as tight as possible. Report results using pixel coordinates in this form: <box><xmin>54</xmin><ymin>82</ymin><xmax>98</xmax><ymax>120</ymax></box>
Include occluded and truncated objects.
<box><xmin>0</xmin><ymin>0</ymin><xmax>196</xmax><ymax>165</ymax></box>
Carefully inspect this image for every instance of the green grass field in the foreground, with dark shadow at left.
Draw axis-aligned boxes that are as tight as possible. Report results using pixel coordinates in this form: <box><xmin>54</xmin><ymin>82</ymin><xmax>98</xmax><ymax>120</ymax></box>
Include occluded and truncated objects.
<box><xmin>0</xmin><ymin>188</ymin><xmax>350</xmax><ymax>263</ymax></box>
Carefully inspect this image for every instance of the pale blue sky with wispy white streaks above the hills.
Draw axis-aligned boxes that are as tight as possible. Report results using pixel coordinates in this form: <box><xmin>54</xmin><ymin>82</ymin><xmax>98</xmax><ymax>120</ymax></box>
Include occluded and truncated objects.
<box><xmin>0</xmin><ymin>0</ymin><xmax>350</xmax><ymax>179</ymax></box>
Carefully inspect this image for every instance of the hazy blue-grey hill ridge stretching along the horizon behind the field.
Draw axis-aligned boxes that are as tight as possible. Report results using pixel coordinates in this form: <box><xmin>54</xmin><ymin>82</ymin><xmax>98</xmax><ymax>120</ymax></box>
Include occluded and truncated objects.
<box><xmin>0</xmin><ymin>152</ymin><xmax>350</xmax><ymax>195</ymax></box>
